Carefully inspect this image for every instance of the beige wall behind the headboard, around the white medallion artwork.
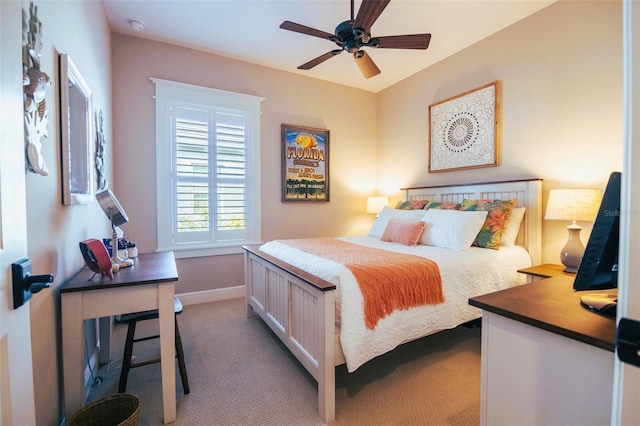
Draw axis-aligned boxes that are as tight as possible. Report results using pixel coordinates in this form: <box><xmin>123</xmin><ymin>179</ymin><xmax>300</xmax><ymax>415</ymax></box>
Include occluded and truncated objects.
<box><xmin>377</xmin><ymin>1</ymin><xmax>622</xmax><ymax>263</ymax></box>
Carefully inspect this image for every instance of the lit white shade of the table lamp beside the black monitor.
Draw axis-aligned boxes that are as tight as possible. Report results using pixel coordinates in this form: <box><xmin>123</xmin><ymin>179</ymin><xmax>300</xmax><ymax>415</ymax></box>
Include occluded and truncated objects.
<box><xmin>544</xmin><ymin>188</ymin><xmax>602</xmax><ymax>222</ymax></box>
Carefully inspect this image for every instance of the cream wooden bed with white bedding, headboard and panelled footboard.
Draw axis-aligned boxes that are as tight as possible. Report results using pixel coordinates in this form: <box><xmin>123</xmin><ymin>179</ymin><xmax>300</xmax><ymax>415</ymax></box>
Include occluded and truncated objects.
<box><xmin>244</xmin><ymin>179</ymin><xmax>542</xmax><ymax>423</ymax></box>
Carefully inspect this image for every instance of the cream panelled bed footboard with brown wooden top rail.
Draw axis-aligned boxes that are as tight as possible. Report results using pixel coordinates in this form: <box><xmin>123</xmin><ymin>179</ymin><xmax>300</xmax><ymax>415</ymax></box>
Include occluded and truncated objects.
<box><xmin>243</xmin><ymin>246</ymin><xmax>336</xmax><ymax>423</ymax></box>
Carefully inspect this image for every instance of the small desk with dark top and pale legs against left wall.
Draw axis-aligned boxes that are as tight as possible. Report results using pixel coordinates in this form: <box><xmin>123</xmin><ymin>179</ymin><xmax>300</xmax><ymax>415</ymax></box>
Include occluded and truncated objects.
<box><xmin>60</xmin><ymin>252</ymin><xmax>178</xmax><ymax>423</ymax></box>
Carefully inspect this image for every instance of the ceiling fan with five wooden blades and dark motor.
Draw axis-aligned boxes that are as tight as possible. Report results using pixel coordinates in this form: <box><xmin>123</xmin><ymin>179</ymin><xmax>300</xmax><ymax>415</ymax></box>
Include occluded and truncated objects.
<box><xmin>280</xmin><ymin>0</ymin><xmax>431</xmax><ymax>78</ymax></box>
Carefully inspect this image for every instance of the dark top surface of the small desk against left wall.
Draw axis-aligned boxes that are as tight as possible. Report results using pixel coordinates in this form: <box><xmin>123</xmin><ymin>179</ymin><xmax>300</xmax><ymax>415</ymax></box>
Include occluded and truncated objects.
<box><xmin>60</xmin><ymin>251</ymin><xmax>178</xmax><ymax>293</ymax></box>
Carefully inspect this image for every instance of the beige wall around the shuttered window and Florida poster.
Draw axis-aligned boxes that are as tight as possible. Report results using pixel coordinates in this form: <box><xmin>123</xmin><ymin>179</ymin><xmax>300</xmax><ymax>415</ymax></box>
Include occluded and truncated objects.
<box><xmin>112</xmin><ymin>34</ymin><xmax>376</xmax><ymax>293</ymax></box>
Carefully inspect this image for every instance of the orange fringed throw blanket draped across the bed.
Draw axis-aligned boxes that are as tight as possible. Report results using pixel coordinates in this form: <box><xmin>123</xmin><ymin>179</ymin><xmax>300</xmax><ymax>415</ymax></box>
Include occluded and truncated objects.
<box><xmin>280</xmin><ymin>238</ymin><xmax>444</xmax><ymax>330</ymax></box>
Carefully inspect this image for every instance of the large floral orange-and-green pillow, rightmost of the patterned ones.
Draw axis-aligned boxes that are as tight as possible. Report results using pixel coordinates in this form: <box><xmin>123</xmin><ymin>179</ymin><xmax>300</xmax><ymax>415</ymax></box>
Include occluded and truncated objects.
<box><xmin>459</xmin><ymin>199</ymin><xmax>516</xmax><ymax>250</ymax></box>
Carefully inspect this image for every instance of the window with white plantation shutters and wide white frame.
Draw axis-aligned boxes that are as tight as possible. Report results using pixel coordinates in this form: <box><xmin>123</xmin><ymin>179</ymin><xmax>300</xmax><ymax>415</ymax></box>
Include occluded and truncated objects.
<box><xmin>152</xmin><ymin>78</ymin><xmax>262</xmax><ymax>257</ymax></box>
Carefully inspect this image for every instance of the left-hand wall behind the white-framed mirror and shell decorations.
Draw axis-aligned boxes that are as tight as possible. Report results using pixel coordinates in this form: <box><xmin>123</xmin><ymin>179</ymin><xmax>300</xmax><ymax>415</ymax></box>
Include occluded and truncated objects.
<box><xmin>16</xmin><ymin>1</ymin><xmax>112</xmax><ymax>425</ymax></box>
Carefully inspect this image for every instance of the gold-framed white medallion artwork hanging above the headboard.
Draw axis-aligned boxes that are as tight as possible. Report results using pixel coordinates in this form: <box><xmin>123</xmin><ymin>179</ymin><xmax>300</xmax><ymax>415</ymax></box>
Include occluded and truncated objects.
<box><xmin>429</xmin><ymin>81</ymin><xmax>502</xmax><ymax>173</ymax></box>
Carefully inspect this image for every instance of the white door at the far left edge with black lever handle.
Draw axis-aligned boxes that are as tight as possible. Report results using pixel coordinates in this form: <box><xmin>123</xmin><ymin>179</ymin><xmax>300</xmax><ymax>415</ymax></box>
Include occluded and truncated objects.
<box><xmin>0</xmin><ymin>0</ymin><xmax>36</xmax><ymax>425</ymax></box>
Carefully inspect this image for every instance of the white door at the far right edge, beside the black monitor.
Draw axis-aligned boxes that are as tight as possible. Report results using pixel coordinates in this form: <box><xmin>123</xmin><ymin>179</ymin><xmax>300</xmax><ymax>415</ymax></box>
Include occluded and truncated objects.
<box><xmin>611</xmin><ymin>0</ymin><xmax>640</xmax><ymax>425</ymax></box>
